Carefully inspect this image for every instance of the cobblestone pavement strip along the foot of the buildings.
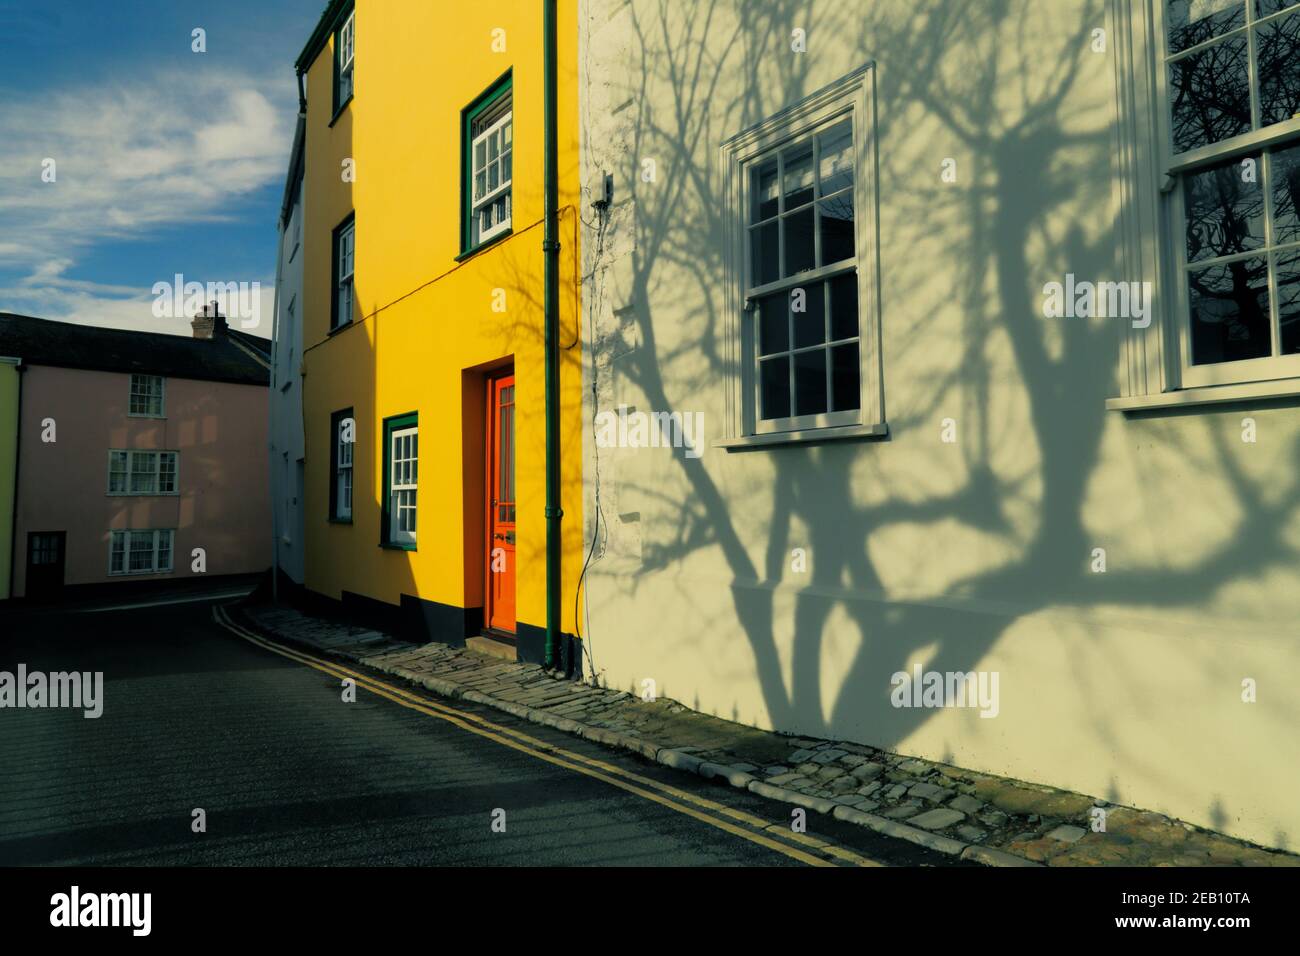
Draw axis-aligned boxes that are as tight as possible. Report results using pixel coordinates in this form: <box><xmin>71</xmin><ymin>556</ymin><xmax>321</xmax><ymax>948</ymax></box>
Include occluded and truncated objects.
<box><xmin>237</xmin><ymin>605</ymin><xmax>1300</xmax><ymax>866</ymax></box>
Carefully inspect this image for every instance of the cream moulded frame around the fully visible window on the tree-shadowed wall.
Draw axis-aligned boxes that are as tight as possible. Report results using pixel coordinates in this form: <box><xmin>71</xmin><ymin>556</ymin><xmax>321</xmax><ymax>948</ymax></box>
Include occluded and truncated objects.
<box><xmin>714</xmin><ymin>62</ymin><xmax>888</xmax><ymax>449</ymax></box>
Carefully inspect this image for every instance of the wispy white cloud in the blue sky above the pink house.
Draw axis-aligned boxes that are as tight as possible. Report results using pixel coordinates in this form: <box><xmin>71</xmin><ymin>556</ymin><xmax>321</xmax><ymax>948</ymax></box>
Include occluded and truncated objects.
<box><xmin>0</xmin><ymin>70</ymin><xmax>287</xmax><ymax>334</ymax></box>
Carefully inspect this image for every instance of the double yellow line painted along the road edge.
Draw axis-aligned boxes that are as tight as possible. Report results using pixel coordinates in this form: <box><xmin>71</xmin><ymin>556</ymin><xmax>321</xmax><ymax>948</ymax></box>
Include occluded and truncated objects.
<box><xmin>212</xmin><ymin>606</ymin><xmax>883</xmax><ymax>866</ymax></box>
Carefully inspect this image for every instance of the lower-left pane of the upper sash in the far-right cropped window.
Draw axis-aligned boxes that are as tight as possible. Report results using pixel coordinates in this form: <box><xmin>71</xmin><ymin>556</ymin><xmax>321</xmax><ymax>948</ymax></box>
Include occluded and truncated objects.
<box><xmin>1169</xmin><ymin>36</ymin><xmax>1251</xmax><ymax>152</ymax></box>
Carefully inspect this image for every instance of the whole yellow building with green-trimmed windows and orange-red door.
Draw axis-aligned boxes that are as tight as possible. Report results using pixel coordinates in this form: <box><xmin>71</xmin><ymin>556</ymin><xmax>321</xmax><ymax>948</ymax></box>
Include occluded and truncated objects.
<box><xmin>290</xmin><ymin>0</ymin><xmax>582</xmax><ymax>665</ymax></box>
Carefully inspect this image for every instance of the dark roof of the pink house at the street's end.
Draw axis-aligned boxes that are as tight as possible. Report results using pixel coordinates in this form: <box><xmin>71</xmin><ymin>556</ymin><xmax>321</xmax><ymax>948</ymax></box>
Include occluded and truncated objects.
<box><xmin>0</xmin><ymin>312</ymin><xmax>270</xmax><ymax>385</ymax></box>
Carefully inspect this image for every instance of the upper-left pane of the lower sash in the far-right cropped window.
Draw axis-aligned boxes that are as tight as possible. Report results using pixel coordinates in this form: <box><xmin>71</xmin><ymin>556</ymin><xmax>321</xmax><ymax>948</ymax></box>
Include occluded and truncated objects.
<box><xmin>1183</xmin><ymin>156</ymin><xmax>1264</xmax><ymax>263</ymax></box>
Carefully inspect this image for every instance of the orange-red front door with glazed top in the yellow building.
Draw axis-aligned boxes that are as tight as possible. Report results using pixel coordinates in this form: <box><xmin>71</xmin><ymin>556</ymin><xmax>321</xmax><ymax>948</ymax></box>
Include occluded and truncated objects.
<box><xmin>488</xmin><ymin>375</ymin><xmax>515</xmax><ymax>633</ymax></box>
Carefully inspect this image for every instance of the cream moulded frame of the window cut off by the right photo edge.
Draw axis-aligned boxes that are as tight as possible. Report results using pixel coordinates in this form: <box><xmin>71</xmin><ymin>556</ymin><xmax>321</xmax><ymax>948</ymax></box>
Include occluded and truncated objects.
<box><xmin>1106</xmin><ymin>0</ymin><xmax>1300</xmax><ymax>411</ymax></box>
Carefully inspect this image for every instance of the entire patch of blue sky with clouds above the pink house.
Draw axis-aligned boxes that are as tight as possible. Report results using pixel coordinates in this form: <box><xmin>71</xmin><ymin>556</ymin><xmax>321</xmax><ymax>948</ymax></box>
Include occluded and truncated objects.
<box><xmin>0</xmin><ymin>0</ymin><xmax>325</xmax><ymax>336</ymax></box>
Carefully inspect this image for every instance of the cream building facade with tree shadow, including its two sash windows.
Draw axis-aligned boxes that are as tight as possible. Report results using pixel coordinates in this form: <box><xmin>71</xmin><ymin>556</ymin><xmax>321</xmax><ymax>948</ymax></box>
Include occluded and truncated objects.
<box><xmin>580</xmin><ymin>0</ymin><xmax>1300</xmax><ymax>849</ymax></box>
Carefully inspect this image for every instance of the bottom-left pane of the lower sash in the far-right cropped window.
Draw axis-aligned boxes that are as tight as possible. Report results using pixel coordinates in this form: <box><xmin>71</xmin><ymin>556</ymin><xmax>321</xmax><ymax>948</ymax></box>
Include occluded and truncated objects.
<box><xmin>1188</xmin><ymin>256</ymin><xmax>1271</xmax><ymax>365</ymax></box>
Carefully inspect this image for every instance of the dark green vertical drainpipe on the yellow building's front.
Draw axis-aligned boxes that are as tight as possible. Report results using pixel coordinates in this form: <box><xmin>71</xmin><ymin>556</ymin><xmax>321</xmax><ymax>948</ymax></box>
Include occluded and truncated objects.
<box><xmin>542</xmin><ymin>0</ymin><xmax>564</xmax><ymax>667</ymax></box>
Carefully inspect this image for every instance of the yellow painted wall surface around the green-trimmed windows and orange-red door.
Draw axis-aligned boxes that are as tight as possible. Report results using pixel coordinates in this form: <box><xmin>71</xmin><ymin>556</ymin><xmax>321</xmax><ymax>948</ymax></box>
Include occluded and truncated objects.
<box><xmin>303</xmin><ymin>0</ymin><xmax>582</xmax><ymax>633</ymax></box>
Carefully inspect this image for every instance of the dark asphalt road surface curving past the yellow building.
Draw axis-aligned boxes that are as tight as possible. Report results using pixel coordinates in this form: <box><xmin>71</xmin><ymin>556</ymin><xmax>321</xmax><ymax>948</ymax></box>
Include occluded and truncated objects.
<box><xmin>0</xmin><ymin>590</ymin><xmax>952</xmax><ymax>866</ymax></box>
